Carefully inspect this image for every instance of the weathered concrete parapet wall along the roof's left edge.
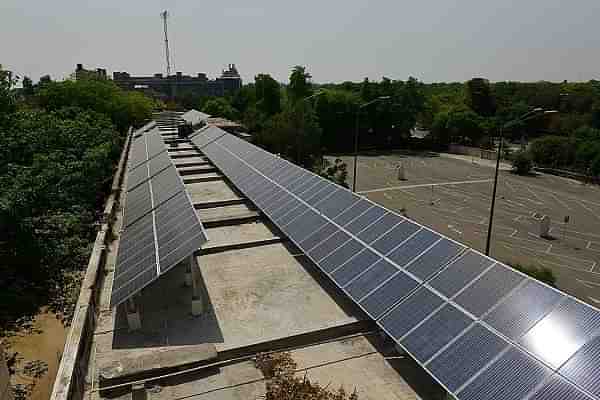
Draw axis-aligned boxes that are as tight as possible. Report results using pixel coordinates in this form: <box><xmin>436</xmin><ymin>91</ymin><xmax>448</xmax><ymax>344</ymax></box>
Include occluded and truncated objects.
<box><xmin>50</xmin><ymin>128</ymin><xmax>132</xmax><ymax>400</ymax></box>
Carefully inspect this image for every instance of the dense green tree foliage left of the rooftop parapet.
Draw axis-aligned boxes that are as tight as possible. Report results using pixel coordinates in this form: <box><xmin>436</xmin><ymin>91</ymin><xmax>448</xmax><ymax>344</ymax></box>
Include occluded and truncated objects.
<box><xmin>0</xmin><ymin>65</ymin><xmax>153</xmax><ymax>336</ymax></box>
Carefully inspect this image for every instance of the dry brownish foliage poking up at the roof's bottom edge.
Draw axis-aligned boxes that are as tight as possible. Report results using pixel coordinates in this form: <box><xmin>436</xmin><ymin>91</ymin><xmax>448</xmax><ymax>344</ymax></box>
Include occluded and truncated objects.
<box><xmin>254</xmin><ymin>352</ymin><xmax>358</xmax><ymax>400</ymax></box>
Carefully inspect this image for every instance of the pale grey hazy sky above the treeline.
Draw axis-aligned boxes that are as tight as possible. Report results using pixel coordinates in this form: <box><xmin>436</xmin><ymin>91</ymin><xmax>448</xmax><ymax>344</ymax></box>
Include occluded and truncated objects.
<box><xmin>0</xmin><ymin>0</ymin><xmax>600</xmax><ymax>82</ymax></box>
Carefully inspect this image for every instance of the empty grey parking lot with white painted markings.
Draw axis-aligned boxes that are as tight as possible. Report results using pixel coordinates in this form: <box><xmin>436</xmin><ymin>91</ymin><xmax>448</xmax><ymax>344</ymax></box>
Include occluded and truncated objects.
<box><xmin>340</xmin><ymin>153</ymin><xmax>600</xmax><ymax>306</ymax></box>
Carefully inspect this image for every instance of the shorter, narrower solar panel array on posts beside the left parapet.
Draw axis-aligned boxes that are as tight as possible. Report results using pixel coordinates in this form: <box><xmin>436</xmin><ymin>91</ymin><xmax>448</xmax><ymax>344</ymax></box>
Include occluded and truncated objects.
<box><xmin>111</xmin><ymin>125</ymin><xmax>207</xmax><ymax>307</ymax></box>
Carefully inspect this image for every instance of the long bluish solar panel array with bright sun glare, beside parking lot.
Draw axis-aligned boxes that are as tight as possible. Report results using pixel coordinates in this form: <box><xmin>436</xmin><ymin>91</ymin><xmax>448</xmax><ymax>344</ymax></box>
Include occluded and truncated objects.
<box><xmin>192</xmin><ymin>129</ymin><xmax>600</xmax><ymax>400</ymax></box>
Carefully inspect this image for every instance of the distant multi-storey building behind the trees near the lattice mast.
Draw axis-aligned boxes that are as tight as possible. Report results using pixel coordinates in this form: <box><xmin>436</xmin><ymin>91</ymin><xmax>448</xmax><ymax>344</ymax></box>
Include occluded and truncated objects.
<box><xmin>113</xmin><ymin>64</ymin><xmax>242</xmax><ymax>99</ymax></box>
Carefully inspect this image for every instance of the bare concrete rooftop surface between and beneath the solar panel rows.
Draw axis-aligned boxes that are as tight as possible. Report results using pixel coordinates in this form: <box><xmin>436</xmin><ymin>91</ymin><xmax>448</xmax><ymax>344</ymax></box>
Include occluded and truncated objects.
<box><xmin>87</xmin><ymin>117</ymin><xmax>441</xmax><ymax>399</ymax></box>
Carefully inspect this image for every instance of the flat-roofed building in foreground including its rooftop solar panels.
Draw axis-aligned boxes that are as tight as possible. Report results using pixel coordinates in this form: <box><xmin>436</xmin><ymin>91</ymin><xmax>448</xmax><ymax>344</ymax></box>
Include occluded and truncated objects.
<box><xmin>52</xmin><ymin>113</ymin><xmax>600</xmax><ymax>400</ymax></box>
